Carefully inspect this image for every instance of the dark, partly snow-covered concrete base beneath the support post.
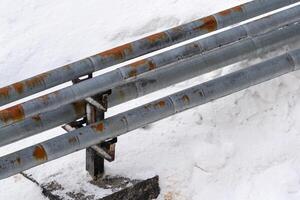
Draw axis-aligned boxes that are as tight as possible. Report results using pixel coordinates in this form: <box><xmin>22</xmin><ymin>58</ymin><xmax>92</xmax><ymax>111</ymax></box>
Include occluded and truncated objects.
<box><xmin>23</xmin><ymin>174</ymin><xmax>160</xmax><ymax>200</ymax></box>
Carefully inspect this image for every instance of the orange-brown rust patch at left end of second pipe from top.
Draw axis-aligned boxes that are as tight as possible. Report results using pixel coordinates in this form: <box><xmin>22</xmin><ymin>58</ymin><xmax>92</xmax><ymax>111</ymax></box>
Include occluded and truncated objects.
<box><xmin>0</xmin><ymin>105</ymin><xmax>25</xmax><ymax>123</ymax></box>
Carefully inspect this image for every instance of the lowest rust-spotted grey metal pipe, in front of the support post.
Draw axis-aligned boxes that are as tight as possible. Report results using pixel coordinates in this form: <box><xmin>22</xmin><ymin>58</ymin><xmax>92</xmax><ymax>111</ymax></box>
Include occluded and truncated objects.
<box><xmin>0</xmin><ymin>49</ymin><xmax>300</xmax><ymax>179</ymax></box>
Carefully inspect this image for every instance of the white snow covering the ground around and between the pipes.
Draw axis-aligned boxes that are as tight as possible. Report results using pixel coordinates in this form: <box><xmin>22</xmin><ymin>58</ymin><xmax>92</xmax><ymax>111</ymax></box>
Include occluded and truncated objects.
<box><xmin>0</xmin><ymin>0</ymin><xmax>300</xmax><ymax>200</ymax></box>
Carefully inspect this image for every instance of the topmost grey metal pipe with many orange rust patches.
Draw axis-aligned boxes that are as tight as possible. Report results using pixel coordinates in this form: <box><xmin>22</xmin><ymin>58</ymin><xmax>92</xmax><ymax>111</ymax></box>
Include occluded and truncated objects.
<box><xmin>0</xmin><ymin>0</ymin><xmax>299</xmax><ymax>106</ymax></box>
